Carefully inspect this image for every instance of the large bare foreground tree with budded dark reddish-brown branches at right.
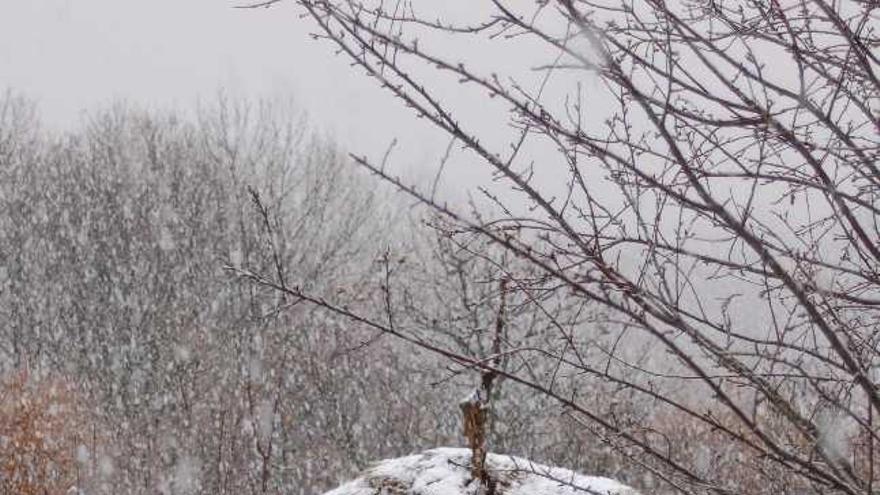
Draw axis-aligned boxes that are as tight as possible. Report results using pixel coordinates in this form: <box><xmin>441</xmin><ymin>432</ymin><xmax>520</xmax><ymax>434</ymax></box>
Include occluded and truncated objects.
<box><xmin>248</xmin><ymin>0</ymin><xmax>880</xmax><ymax>494</ymax></box>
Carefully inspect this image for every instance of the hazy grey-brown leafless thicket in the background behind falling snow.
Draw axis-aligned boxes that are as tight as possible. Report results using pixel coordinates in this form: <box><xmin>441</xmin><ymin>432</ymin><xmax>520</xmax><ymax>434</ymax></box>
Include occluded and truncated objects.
<box><xmin>0</xmin><ymin>93</ymin><xmax>638</xmax><ymax>495</ymax></box>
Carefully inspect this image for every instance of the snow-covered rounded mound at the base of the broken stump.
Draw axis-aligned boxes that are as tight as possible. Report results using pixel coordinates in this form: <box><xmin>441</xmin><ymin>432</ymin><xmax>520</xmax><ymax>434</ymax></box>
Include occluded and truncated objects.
<box><xmin>325</xmin><ymin>448</ymin><xmax>638</xmax><ymax>495</ymax></box>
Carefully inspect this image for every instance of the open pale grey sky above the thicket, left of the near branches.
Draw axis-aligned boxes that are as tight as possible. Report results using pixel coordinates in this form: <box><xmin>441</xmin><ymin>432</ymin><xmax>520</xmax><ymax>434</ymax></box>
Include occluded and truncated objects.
<box><xmin>0</xmin><ymin>0</ymin><xmax>454</xmax><ymax>173</ymax></box>
